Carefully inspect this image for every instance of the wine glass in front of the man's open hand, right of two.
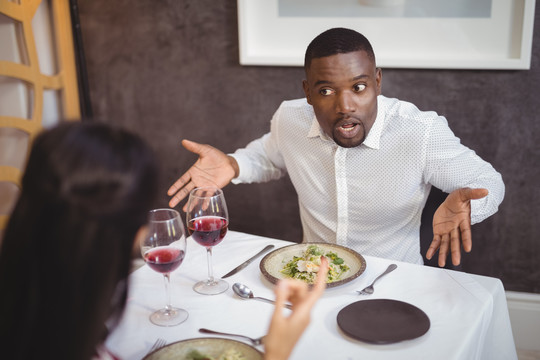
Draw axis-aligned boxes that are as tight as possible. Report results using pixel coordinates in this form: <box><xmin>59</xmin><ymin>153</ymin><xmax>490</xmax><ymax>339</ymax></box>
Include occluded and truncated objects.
<box><xmin>186</xmin><ymin>187</ymin><xmax>229</xmax><ymax>295</ymax></box>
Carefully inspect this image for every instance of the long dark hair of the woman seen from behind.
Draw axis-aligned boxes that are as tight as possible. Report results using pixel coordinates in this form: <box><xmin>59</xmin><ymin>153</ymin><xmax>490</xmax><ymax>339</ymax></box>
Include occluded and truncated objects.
<box><xmin>0</xmin><ymin>123</ymin><xmax>158</xmax><ymax>359</ymax></box>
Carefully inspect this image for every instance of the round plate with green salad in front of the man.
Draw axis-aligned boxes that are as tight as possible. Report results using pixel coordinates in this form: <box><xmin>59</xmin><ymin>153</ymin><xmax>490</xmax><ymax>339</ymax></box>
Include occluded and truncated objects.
<box><xmin>259</xmin><ymin>243</ymin><xmax>366</xmax><ymax>287</ymax></box>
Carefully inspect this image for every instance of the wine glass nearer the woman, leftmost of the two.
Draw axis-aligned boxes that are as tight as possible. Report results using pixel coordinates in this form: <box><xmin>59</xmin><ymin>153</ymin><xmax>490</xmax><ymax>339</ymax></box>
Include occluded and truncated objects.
<box><xmin>141</xmin><ymin>209</ymin><xmax>188</xmax><ymax>326</ymax></box>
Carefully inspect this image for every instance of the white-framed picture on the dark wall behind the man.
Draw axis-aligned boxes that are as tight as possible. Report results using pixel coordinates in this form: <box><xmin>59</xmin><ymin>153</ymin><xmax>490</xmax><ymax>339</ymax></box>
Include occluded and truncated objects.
<box><xmin>238</xmin><ymin>0</ymin><xmax>535</xmax><ymax>69</ymax></box>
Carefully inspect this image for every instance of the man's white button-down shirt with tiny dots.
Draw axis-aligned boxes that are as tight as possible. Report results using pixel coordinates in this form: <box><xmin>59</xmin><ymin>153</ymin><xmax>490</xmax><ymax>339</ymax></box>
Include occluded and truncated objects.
<box><xmin>232</xmin><ymin>96</ymin><xmax>504</xmax><ymax>264</ymax></box>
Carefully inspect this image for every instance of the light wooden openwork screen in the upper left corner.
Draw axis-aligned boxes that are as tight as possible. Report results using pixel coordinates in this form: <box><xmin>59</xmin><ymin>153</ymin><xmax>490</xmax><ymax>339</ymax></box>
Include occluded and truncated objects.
<box><xmin>0</xmin><ymin>0</ymin><xmax>81</xmax><ymax>230</ymax></box>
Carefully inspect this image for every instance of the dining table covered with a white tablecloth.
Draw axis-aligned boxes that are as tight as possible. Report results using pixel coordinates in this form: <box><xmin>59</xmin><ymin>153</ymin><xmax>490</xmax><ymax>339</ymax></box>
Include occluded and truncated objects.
<box><xmin>105</xmin><ymin>230</ymin><xmax>517</xmax><ymax>360</ymax></box>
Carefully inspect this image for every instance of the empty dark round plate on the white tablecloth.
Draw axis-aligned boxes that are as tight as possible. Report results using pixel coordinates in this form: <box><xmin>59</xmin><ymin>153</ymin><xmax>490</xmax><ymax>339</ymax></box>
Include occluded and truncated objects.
<box><xmin>337</xmin><ymin>299</ymin><xmax>430</xmax><ymax>344</ymax></box>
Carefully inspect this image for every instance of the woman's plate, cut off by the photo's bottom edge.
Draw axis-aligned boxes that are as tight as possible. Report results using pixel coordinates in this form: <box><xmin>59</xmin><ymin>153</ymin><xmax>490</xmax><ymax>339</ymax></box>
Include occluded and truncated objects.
<box><xmin>143</xmin><ymin>338</ymin><xmax>263</xmax><ymax>360</ymax></box>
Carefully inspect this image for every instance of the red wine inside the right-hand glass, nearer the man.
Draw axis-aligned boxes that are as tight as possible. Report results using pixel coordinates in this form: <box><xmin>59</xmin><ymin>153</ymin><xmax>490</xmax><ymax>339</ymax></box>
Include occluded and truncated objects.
<box><xmin>188</xmin><ymin>216</ymin><xmax>229</xmax><ymax>247</ymax></box>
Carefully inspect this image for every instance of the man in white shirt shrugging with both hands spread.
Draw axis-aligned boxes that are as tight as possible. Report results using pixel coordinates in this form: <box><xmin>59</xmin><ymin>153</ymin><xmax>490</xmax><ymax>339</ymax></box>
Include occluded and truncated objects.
<box><xmin>168</xmin><ymin>28</ymin><xmax>504</xmax><ymax>266</ymax></box>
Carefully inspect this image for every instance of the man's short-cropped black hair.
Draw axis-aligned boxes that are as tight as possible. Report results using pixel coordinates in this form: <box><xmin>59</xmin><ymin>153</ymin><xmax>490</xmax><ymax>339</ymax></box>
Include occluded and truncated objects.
<box><xmin>304</xmin><ymin>28</ymin><xmax>375</xmax><ymax>70</ymax></box>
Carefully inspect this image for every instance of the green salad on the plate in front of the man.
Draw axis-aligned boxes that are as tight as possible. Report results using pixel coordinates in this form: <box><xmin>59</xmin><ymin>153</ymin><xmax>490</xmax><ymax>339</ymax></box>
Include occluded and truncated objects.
<box><xmin>281</xmin><ymin>245</ymin><xmax>350</xmax><ymax>284</ymax></box>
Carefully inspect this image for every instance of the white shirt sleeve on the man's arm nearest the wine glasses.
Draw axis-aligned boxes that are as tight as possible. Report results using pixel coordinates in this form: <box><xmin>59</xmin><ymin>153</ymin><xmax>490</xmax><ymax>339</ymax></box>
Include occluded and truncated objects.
<box><xmin>229</xmin><ymin>104</ymin><xmax>287</xmax><ymax>184</ymax></box>
